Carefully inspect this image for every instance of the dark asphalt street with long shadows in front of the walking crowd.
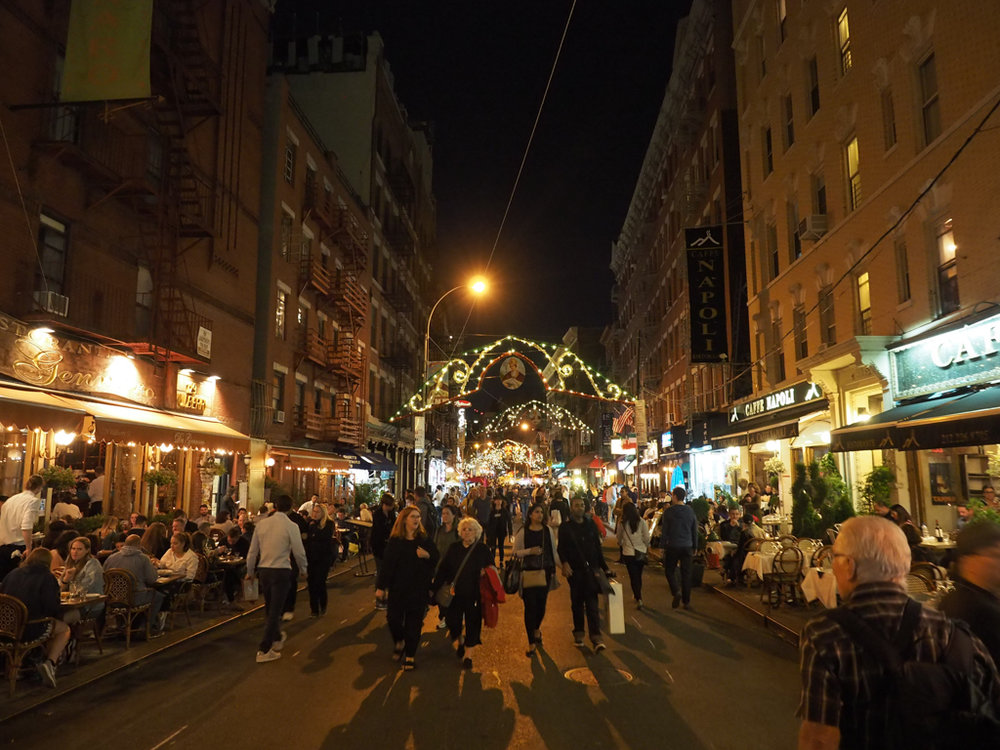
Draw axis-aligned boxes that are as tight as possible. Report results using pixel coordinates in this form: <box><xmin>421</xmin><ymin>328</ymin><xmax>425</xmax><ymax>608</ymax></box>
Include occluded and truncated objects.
<box><xmin>0</xmin><ymin>565</ymin><xmax>798</xmax><ymax>750</ymax></box>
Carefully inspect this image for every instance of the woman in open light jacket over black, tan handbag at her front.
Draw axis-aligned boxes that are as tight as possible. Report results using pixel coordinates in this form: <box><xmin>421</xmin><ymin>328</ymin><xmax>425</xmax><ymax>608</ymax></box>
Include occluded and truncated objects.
<box><xmin>511</xmin><ymin>503</ymin><xmax>559</xmax><ymax>657</ymax></box>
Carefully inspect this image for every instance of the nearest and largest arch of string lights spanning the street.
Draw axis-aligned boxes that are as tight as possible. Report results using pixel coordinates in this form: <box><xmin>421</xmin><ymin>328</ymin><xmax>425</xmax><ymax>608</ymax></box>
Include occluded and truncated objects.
<box><xmin>390</xmin><ymin>336</ymin><xmax>633</xmax><ymax>421</ymax></box>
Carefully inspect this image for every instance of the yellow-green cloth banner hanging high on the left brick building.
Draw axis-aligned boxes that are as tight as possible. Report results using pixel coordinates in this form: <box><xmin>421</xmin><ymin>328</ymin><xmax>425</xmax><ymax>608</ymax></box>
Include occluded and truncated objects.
<box><xmin>59</xmin><ymin>0</ymin><xmax>153</xmax><ymax>102</ymax></box>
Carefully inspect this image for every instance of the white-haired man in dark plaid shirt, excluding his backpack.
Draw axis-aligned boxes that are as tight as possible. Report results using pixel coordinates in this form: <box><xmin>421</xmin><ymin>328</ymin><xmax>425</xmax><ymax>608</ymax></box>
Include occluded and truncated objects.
<box><xmin>798</xmin><ymin>516</ymin><xmax>1000</xmax><ymax>750</ymax></box>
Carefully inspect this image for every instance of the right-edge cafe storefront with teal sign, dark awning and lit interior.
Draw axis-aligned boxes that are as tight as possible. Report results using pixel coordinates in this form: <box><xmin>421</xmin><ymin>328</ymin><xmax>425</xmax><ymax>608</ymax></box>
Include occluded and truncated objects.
<box><xmin>832</xmin><ymin>315</ymin><xmax>1000</xmax><ymax>529</ymax></box>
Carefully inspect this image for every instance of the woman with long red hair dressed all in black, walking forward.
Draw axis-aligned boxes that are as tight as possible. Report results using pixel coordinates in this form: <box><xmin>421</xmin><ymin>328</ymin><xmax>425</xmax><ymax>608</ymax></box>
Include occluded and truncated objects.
<box><xmin>375</xmin><ymin>505</ymin><xmax>438</xmax><ymax>671</ymax></box>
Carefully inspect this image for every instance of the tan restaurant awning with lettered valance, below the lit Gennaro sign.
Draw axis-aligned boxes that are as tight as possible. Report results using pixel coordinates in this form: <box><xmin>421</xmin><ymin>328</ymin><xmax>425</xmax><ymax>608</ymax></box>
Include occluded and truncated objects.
<box><xmin>71</xmin><ymin>396</ymin><xmax>250</xmax><ymax>453</ymax></box>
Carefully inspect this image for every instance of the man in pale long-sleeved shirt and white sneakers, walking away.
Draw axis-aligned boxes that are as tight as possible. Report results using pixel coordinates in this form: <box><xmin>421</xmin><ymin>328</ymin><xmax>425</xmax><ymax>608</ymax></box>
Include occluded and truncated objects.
<box><xmin>246</xmin><ymin>495</ymin><xmax>309</xmax><ymax>664</ymax></box>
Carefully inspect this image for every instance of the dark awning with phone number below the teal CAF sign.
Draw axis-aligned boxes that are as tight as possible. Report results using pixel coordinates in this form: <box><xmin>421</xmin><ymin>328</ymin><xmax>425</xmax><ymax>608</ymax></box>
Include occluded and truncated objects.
<box><xmin>830</xmin><ymin>387</ymin><xmax>1000</xmax><ymax>451</ymax></box>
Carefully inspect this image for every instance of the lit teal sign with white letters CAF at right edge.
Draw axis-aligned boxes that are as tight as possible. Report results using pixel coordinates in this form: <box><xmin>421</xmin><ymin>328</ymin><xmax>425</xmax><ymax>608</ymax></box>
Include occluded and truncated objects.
<box><xmin>889</xmin><ymin>315</ymin><xmax>1000</xmax><ymax>401</ymax></box>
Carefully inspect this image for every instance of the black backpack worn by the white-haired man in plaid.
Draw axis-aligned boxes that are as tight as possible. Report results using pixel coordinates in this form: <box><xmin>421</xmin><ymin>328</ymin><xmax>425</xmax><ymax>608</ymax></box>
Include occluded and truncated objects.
<box><xmin>828</xmin><ymin>599</ymin><xmax>1000</xmax><ymax>750</ymax></box>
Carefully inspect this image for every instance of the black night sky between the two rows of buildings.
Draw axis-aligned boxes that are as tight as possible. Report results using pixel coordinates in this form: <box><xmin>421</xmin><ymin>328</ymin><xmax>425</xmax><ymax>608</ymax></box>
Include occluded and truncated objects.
<box><xmin>276</xmin><ymin>0</ymin><xmax>691</xmax><ymax>342</ymax></box>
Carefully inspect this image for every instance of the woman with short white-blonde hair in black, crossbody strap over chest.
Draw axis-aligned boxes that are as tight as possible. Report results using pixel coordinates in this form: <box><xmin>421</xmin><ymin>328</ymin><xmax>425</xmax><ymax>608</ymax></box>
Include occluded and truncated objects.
<box><xmin>432</xmin><ymin>518</ymin><xmax>493</xmax><ymax>669</ymax></box>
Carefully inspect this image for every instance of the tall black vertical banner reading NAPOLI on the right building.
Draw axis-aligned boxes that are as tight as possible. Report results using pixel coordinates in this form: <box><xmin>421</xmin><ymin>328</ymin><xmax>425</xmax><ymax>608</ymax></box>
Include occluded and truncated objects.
<box><xmin>684</xmin><ymin>226</ymin><xmax>729</xmax><ymax>362</ymax></box>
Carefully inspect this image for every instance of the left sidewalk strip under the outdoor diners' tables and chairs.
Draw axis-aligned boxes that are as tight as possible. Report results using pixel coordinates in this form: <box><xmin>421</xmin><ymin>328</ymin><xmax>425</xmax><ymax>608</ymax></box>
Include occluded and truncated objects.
<box><xmin>0</xmin><ymin>558</ymin><xmax>368</xmax><ymax>723</ymax></box>
